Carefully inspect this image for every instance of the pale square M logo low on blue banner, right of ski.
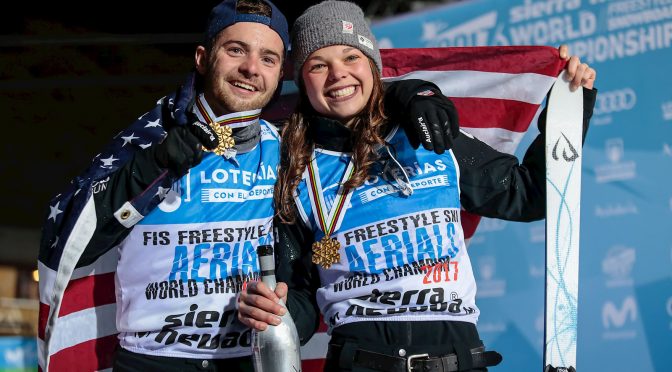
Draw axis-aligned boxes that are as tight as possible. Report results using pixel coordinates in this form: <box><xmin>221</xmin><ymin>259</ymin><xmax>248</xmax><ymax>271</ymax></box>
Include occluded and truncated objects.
<box><xmin>602</xmin><ymin>296</ymin><xmax>638</xmax><ymax>340</ymax></box>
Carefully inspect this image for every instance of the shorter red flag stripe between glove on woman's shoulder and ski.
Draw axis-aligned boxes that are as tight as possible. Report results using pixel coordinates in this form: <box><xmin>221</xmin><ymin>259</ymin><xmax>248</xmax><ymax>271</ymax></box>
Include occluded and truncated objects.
<box><xmin>450</xmin><ymin>97</ymin><xmax>539</xmax><ymax>133</ymax></box>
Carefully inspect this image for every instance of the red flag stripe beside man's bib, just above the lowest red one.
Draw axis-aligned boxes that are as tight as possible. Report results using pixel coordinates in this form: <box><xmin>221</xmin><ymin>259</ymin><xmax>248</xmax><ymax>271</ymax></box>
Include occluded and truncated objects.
<box><xmin>58</xmin><ymin>273</ymin><xmax>117</xmax><ymax>317</ymax></box>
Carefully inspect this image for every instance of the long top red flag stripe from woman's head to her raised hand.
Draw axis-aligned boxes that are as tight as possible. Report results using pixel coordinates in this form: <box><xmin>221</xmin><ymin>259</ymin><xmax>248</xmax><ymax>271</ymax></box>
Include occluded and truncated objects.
<box><xmin>380</xmin><ymin>46</ymin><xmax>566</xmax><ymax>77</ymax></box>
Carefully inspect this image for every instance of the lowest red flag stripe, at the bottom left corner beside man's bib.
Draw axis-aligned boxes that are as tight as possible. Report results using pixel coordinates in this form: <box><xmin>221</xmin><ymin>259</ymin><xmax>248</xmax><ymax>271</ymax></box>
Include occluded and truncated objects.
<box><xmin>49</xmin><ymin>334</ymin><xmax>119</xmax><ymax>371</ymax></box>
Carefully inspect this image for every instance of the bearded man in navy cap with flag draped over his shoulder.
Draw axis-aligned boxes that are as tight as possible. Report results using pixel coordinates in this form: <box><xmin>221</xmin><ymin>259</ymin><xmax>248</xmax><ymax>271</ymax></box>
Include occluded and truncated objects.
<box><xmin>39</xmin><ymin>0</ymin><xmax>456</xmax><ymax>371</ymax></box>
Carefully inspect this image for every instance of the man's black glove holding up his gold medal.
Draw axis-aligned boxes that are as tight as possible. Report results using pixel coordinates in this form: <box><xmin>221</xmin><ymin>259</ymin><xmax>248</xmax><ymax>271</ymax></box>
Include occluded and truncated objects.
<box><xmin>149</xmin><ymin>121</ymin><xmax>219</xmax><ymax>177</ymax></box>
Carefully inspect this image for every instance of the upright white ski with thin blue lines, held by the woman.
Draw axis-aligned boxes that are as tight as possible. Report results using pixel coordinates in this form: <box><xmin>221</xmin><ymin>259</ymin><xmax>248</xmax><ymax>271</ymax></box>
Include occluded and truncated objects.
<box><xmin>544</xmin><ymin>71</ymin><xmax>583</xmax><ymax>372</ymax></box>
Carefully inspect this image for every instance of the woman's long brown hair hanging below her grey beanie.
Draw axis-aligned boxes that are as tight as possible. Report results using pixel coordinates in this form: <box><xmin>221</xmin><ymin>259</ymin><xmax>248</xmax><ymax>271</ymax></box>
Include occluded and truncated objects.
<box><xmin>274</xmin><ymin>59</ymin><xmax>387</xmax><ymax>223</ymax></box>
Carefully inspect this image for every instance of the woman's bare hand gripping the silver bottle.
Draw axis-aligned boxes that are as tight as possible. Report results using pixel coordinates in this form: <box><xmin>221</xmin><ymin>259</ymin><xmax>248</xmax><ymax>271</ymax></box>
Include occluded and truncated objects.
<box><xmin>238</xmin><ymin>282</ymin><xmax>287</xmax><ymax>331</ymax></box>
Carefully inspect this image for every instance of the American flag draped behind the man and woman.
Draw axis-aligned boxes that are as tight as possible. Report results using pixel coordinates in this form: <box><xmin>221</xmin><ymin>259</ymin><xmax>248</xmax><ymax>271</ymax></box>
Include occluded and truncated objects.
<box><xmin>38</xmin><ymin>47</ymin><xmax>565</xmax><ymax>371</ymax></box>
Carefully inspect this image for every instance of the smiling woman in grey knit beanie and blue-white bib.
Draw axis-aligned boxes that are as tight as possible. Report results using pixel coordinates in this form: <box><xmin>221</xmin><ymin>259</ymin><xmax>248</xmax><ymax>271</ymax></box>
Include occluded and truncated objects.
<box><xmin>239</xmin><ymin>1</ymin><xmax>596</xmax><ymax>371</ymax></box>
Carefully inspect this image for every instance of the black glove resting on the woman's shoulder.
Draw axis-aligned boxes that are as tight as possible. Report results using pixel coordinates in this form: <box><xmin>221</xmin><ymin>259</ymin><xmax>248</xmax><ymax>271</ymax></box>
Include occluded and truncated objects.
<box><xmin>403</xmin><ymin>89</ymin><xmax>460</xmax><ymax>154</ymax></box>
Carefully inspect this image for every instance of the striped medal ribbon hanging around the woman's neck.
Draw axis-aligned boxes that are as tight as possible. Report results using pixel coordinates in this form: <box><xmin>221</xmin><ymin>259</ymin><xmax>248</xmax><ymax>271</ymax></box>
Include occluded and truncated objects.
<box><xmin>307</xmin><ymin>150</ymin><xmax>355</xmax><ymax>238</ymax></box>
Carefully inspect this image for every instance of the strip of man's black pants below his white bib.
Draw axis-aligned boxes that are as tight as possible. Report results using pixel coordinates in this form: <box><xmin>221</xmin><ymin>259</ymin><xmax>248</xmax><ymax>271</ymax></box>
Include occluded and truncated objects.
<box><xmin>112</xmin><ymin>347</ymin><xmax>253</xmax><ymax>372</ymax></box>
